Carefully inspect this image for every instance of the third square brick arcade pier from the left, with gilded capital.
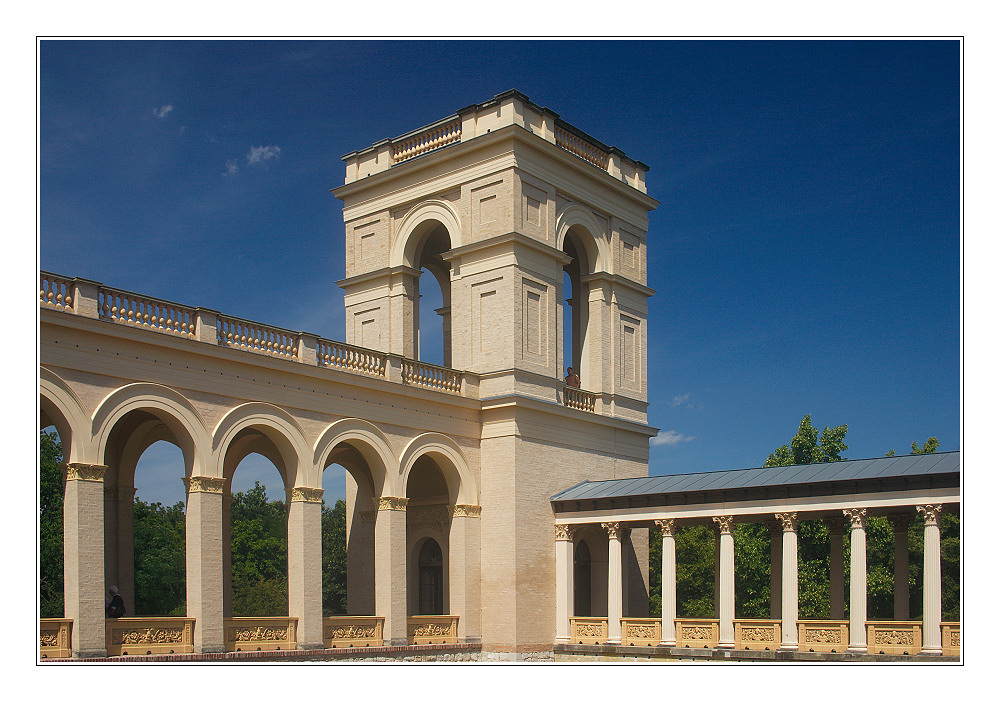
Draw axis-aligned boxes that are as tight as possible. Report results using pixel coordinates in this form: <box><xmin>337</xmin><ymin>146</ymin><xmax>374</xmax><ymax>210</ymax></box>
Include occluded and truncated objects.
<box><xmin>288</xmin><ymin>487</ymin><xmax>324</xmax><ymax>649</ymax></box>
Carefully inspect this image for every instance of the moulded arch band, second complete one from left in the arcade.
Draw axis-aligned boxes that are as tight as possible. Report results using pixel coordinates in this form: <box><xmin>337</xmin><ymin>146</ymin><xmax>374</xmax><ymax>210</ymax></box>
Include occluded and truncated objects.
<box><xmin>214</xmin><ymin>402</ymin><xmax>312</xmax><ymax>488</ymax></box>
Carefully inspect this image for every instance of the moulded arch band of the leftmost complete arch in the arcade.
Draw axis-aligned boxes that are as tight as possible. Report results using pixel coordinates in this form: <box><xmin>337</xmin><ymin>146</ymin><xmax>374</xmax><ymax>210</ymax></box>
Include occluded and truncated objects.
<box><xmin>91</xmin><ymin>383</ymin><xmax>212</xmax><ymax>475</ymax></box>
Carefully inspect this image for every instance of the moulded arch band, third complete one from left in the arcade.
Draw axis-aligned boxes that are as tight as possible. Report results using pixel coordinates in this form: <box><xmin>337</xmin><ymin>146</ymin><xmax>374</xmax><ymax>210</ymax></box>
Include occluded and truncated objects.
<box><xmin>310</xmin><ymin>418</ymin><xmax>404</xmax><ymax>497</ymax></box>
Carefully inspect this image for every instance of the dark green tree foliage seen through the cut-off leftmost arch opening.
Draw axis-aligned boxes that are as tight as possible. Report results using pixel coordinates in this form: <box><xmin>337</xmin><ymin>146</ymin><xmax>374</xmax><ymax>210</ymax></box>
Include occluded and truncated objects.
<box><xmin>38</xmin><ymin>430</ymin><xmax>65</xmax><ymax>617</ymax></box>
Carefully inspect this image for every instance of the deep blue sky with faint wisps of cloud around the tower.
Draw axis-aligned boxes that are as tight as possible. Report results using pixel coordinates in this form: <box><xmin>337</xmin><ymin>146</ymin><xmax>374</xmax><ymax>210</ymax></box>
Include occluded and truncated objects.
<box><xmin>39</xmin><ymin>41</ymin><xmax>961</xmax><ymax>502</ymax></box>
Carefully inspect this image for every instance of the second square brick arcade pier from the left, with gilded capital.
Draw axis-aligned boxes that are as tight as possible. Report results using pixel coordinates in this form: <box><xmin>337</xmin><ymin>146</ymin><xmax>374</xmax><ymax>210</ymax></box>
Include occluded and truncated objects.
<box><xmin>185</xmin><ymin>476</ymin><xmax>226</xmax><ymax>653</ymax></box>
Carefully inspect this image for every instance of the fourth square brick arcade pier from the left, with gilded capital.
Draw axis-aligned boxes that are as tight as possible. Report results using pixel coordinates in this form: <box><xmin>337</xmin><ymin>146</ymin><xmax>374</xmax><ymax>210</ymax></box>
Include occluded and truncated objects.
<box><xmin>375</xmin><ymin>497</ymin><xmax>409</xmax><ymax>646</ymax></box>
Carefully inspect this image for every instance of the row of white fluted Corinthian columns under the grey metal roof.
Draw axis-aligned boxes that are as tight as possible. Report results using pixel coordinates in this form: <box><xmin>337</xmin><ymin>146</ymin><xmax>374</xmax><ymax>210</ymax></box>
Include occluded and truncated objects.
<box><xmin>555</xmin><ymin>504</ymin><xmax>942</xmax><ymax>655</ymax></box>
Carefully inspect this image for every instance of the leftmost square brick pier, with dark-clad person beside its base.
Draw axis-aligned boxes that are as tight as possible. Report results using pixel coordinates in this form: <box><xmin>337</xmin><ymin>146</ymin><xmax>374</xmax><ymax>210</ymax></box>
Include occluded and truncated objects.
<box><xmin>63</xmin><ymin>463</ymin><xmax>107</xmax><ymax>658</ymax></box>
